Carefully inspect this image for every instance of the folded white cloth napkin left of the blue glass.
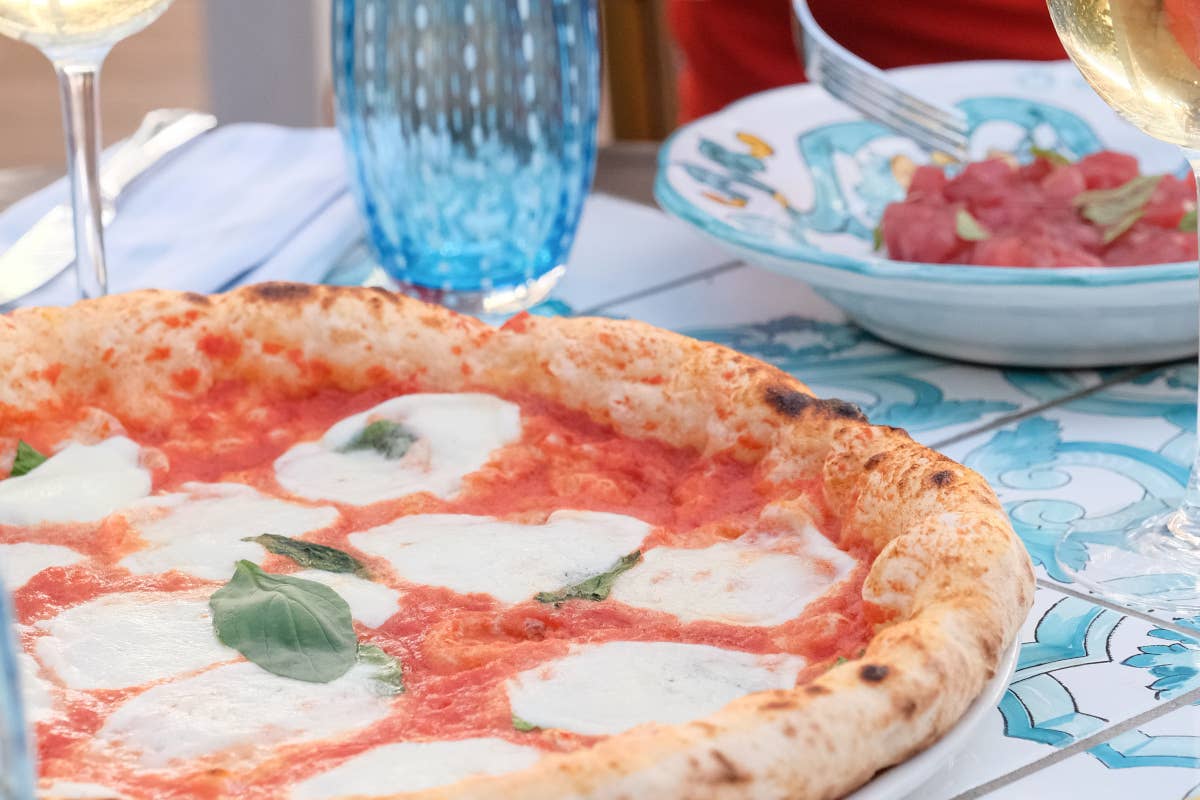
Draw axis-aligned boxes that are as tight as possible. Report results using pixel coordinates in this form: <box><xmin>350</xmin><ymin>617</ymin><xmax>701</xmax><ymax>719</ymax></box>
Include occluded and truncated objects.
<box><xmin>0</xmin><ymin>125</ymin><xmax>362</xmax><ymax>306</ymax></box>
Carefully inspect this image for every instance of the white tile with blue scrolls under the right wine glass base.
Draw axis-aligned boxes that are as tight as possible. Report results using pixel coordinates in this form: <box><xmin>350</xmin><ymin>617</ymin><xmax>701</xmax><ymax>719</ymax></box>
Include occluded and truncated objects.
<box><xmin>944</xmin><ymin>365</ymin><xmax>1200</xmax><ymax>609</ymax></box>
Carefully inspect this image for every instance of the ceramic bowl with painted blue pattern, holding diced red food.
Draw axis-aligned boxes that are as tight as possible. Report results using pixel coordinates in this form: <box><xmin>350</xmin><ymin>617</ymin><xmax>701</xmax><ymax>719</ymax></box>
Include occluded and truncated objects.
<box><xmin>655</xmin><ymin>61</ymin><xmax>1200</xmax><ymax>367</ymax></box>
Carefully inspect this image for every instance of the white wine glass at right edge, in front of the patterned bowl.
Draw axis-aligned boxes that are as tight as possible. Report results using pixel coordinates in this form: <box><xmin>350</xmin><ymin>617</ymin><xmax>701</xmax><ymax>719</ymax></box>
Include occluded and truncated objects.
<box><xmin>1048</xmin><ymin>0</ymin><xmax>1200</xmax><ymax>615</ymax></box>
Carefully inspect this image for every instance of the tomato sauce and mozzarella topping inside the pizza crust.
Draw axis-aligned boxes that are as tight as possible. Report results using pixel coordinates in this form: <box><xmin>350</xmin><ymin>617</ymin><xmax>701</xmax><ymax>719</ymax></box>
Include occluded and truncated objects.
<box><xmin>0</xmin><ymin>381</ymin><xmax>876</xmax><ymax>800</ymax></box>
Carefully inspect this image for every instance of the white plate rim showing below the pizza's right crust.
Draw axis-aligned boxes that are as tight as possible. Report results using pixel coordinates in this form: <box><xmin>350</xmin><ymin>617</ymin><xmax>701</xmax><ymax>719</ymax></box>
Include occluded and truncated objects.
<box><xmin>846</xmin><ymin>643</ymin><xmax>1020</xmax><ymax>800</ymax></box>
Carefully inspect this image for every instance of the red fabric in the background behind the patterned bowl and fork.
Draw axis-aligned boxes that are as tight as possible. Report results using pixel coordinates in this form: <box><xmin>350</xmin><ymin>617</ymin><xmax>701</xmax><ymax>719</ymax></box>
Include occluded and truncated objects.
<box><xmin>667</xmin><ymin>0</ymin><xmax>1066</xmax><ymax>121</ymax></box>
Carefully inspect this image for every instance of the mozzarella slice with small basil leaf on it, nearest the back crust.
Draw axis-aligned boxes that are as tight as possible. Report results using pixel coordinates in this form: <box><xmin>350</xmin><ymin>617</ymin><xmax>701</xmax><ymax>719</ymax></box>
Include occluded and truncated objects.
<box><xmin>275</xmin><ymin>393</ymin><xmax>521</xmax><ymax>505</ymax></box>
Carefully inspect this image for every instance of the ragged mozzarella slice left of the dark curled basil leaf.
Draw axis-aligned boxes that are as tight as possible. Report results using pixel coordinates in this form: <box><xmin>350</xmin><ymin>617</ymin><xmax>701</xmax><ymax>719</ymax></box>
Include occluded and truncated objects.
<box><xmin>120</xmin><ymin>483</ymin><xmax>338</xmax><ymax>581</ymax></box>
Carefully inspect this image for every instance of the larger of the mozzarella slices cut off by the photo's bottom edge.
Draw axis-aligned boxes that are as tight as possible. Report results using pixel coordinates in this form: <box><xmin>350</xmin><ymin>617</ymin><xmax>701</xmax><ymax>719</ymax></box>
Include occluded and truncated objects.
<box><xmin>292</xmin><ymin>736</ymin><xmax>541</xmax><ymax>800</ymax></box>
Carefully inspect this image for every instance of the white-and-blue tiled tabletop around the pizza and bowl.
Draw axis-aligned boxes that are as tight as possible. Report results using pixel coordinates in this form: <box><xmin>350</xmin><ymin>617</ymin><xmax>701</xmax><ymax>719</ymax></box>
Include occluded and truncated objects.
<box><xmin>0</xmin><ymin>144</ymin><xmax>1200</xmax><ymax>800</ymax></box>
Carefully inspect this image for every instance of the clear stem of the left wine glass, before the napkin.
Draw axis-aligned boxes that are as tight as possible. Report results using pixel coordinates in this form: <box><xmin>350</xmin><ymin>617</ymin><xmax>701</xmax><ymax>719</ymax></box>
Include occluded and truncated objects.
<box><xmin>54</xmin><ymin>62</ymin><xmax>108</xmax><ymax>297</ymax></box>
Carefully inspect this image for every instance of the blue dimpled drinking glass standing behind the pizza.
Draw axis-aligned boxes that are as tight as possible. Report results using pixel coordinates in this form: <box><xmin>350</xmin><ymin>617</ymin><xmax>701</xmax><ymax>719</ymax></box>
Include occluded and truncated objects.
<box><xmin>332</xmin><ymin>0</ymin><xmax>600</xmax><ymax>312</ymax></box>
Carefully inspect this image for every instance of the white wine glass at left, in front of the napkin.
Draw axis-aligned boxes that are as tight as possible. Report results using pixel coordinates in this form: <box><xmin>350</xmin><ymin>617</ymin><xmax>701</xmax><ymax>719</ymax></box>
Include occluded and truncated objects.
<box><xmin>0</xmin><ymin>0</ymin><xmax>172</xmax><ymax>297</ymax></box>
